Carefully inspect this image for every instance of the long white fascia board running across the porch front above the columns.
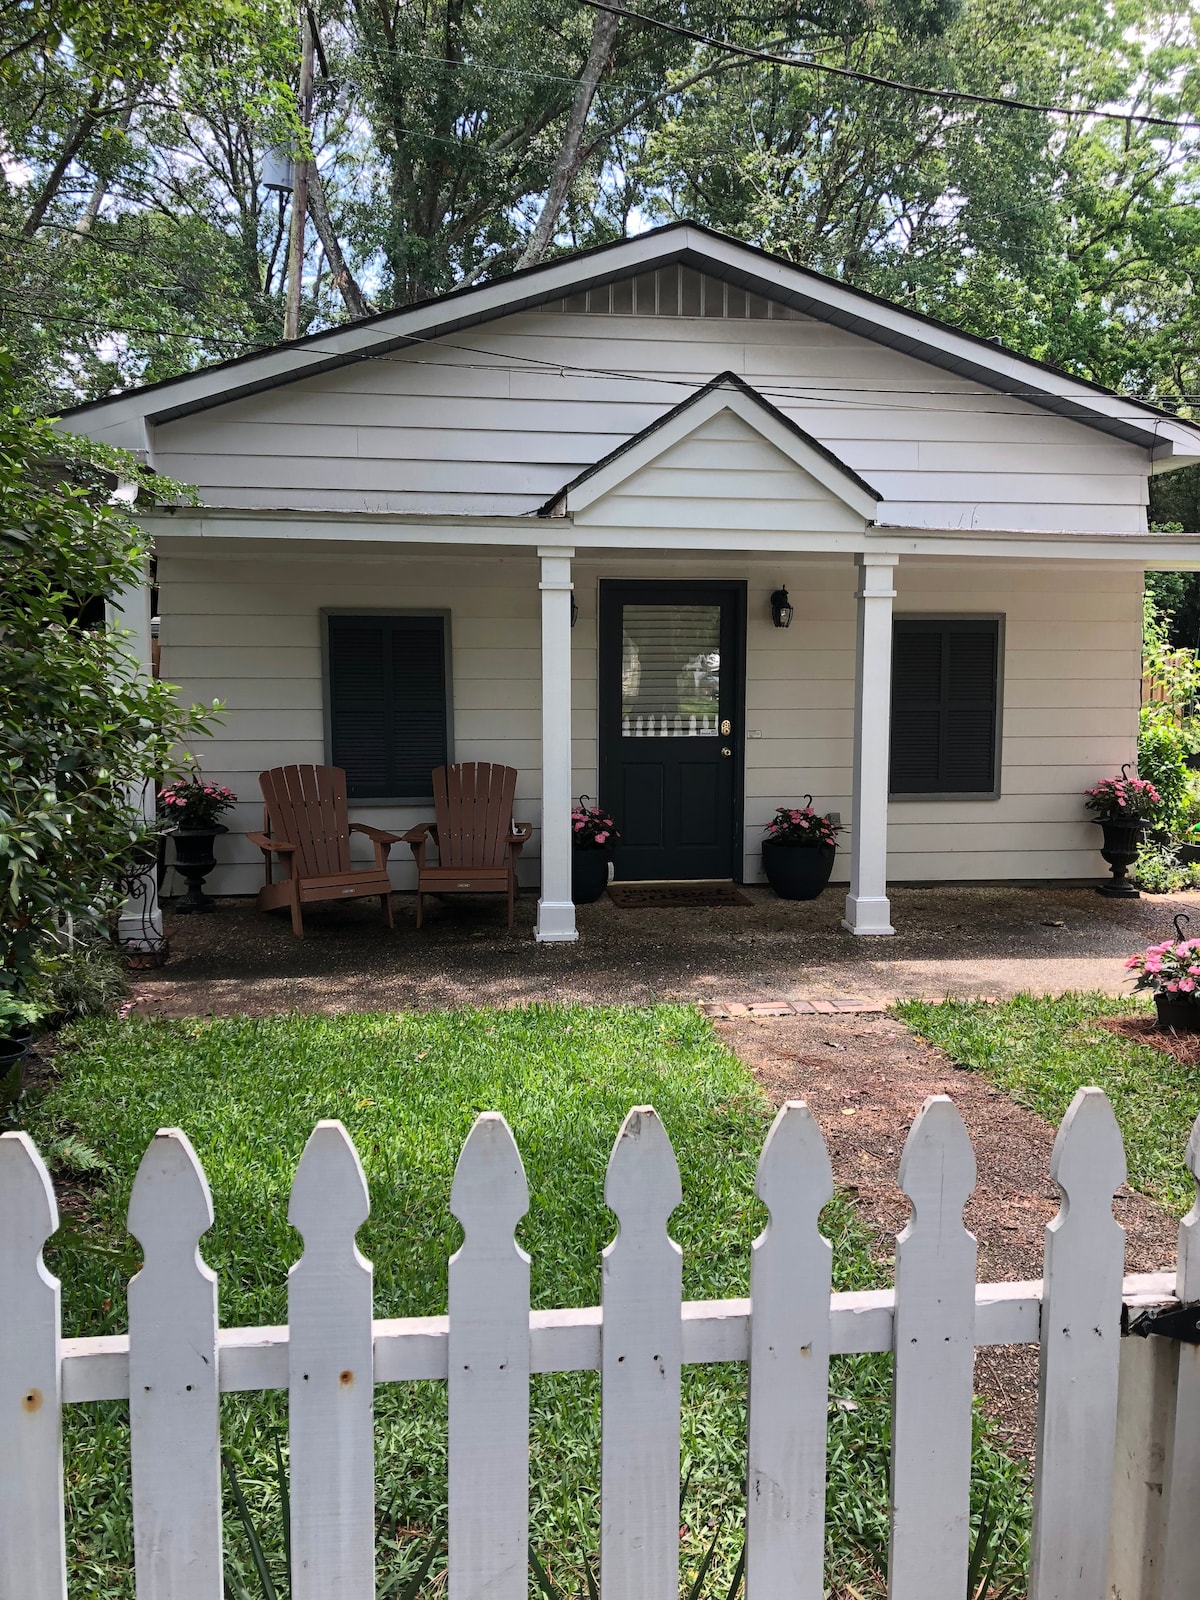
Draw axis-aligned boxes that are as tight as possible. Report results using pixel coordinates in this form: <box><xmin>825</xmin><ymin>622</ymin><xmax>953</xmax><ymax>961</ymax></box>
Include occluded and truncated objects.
<box><xmin>139</xmin><ymin>509</ymin><xmax>1200</xmax><ymax>571</ymax></box>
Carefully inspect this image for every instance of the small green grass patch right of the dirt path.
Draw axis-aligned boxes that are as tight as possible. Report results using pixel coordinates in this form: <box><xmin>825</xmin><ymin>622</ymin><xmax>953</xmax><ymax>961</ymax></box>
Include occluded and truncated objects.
<box><xmin>896</xmin><ymin>994</ymin><xmax>1200</xmax><ymax>1216</ymax></box>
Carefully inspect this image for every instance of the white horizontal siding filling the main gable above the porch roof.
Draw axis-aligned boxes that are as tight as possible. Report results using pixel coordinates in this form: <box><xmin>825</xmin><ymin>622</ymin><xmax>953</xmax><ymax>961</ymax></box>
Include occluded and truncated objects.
<box><xmin>155</xmin><ymin>310</ymin><xmax>1147</xmax><ymax>533</ymax></box>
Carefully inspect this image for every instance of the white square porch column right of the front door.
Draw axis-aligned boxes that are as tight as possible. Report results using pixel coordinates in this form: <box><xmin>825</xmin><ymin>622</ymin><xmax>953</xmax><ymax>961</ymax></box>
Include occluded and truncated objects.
<box><xmin>842</xmin><ymin>550</ymin><xmax>899</xmax><ymax>934</ymax></box>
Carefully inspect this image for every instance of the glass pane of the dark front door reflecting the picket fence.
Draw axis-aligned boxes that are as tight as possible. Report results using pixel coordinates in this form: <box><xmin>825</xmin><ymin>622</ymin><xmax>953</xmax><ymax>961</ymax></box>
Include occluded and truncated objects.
<box><xmin>621</xmin><ymin>605</ymin><xmax>722</xmax><ymax>739</ymax></box>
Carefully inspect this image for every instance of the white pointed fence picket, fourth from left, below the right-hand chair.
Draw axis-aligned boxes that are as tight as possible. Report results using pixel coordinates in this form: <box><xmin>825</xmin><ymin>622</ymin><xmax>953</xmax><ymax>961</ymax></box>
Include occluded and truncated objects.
<box><xmin>448</xmin><ymin>1112</ymin><xmax>530</xmax><ymax>1600</ymax></box>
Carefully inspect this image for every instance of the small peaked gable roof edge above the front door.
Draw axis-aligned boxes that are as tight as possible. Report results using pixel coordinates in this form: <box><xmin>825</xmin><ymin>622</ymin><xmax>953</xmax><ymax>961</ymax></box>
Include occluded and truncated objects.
<box><xmin>538</xmin><ymin>373</ymin><xmax>883</xmax><ymax>522</ymax></box>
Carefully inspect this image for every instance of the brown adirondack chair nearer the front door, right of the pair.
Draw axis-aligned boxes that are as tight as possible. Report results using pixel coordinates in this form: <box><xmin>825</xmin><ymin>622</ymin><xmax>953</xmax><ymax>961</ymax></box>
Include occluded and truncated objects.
<box><xmin>405</xmin><ymin>762</ymin><xmax>533</xmax><ymax>928</ymax></box>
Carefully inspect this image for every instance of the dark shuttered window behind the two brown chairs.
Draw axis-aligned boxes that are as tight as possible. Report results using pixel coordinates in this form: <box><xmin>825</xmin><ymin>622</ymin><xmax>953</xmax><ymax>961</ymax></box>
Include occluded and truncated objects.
<box><xmin>326</xmin><ymin>613</ymin><xmax>450</xmax><ymax>800</ymax></box>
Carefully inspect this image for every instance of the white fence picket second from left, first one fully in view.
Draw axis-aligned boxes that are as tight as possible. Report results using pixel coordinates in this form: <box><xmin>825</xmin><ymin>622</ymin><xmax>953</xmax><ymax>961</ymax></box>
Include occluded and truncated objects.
<box><xmin>130</xmin><ymin>1128</ymin><xmax>224</xmax><ymax>1600</ymax></box>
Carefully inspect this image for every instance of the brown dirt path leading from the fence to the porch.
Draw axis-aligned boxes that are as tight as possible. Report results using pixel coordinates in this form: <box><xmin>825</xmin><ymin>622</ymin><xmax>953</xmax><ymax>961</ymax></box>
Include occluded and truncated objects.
<box><xmin>729</xmin><ymin>1016</ymin><xmax>1176</xmax><ymax>1454</ymax></box>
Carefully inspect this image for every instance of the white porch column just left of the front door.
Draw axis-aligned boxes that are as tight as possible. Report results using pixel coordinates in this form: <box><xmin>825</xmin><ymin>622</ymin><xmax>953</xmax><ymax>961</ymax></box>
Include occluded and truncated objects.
<box><xmin>536</xmin><ymin>544</ymin><xmax>579</xmax><ymax>944</ymax></box>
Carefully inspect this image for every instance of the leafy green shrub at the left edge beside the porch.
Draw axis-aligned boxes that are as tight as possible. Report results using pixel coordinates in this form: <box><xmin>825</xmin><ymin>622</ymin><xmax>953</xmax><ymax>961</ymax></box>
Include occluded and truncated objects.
<box><xmin>0</xmin><ymin>357</ymin><xmax>216</xmax><ymax>992</ymax></box>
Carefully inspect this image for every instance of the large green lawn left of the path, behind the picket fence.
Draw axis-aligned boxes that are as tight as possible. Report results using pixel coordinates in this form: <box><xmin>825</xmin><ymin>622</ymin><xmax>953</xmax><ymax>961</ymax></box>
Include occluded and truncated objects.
<box><xmin>26</xmin><ymin>1006</ymin><xmax>1027</xmax><ymax>1600</ymax></box>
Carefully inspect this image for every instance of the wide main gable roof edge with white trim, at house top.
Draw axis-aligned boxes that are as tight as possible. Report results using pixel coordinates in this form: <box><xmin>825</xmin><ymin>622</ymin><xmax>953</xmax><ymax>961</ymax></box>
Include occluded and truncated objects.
<box><xmin>61</xmin><ymin>222</ymin><xmax>1200</xmax><ymax>459</ymax></box>
